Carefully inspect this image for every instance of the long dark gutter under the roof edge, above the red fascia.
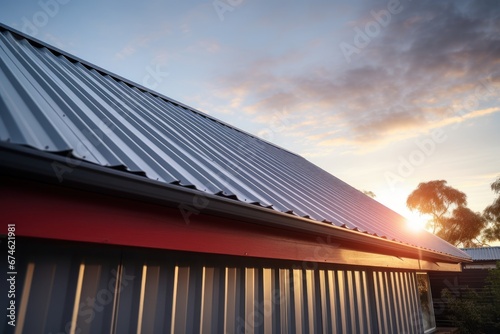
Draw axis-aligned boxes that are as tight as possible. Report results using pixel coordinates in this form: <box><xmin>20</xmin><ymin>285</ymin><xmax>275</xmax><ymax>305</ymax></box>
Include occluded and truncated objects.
<box><xmin>0</xmin><ymin>143</ymin><xmax>470</xmax><ymax>270</ymax></box>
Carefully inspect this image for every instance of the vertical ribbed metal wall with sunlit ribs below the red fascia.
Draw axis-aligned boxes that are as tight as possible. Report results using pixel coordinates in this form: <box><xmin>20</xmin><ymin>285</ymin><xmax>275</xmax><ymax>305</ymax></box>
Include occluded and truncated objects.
<box><xmin>2</xmin><ymin>241</ymin><xmax>423</xmax><ymax>334</ymax></box>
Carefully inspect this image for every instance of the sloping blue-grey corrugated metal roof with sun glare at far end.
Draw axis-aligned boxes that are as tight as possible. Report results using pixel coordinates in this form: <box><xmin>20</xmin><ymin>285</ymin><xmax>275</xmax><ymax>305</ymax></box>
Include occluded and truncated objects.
<box><xmin>0</xmin><ymin>27</ymin><xmax>467</xmax><ymax>258</ymax></box>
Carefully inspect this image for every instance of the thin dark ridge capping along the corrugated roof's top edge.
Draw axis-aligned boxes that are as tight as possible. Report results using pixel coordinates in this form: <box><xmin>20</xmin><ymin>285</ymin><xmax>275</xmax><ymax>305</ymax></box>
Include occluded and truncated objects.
<box><xmin>0</xmin><ymin>22</ymin><xmax>303</xmax><ymax>158</ymax></box>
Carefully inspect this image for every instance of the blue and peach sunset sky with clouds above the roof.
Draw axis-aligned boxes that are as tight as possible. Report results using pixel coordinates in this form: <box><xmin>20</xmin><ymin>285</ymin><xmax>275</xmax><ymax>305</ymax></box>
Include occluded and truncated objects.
<box><xmin>0</xmin><ymin>0</ymin><xmax>500</xmax><ymax>235</ymax></box>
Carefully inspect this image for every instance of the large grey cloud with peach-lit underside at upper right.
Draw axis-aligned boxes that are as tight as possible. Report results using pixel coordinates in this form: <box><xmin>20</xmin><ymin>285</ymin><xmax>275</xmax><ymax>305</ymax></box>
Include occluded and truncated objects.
<box><xmin>203</xmin><ymin>1</ymin><xmax>500</xmax><ymax>150</ymax></box>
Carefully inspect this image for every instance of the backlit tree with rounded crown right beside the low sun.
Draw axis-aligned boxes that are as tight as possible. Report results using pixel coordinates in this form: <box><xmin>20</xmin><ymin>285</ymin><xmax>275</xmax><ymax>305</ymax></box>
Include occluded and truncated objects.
<box><xmin>406</xmin><ymin>180</ymin><xmax>485</xmax><ymax>247</ymax></box>
